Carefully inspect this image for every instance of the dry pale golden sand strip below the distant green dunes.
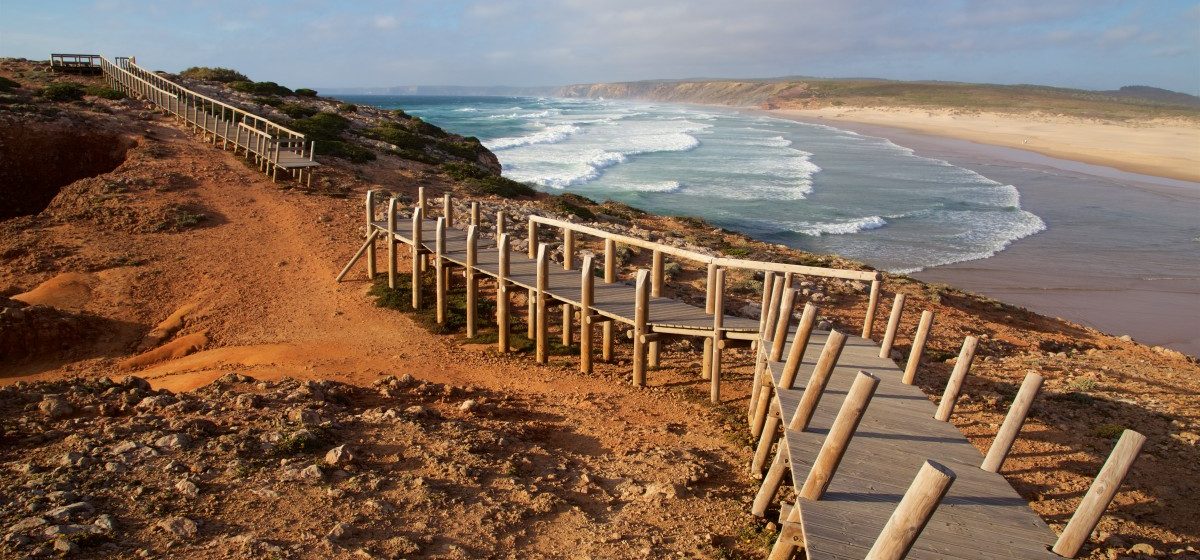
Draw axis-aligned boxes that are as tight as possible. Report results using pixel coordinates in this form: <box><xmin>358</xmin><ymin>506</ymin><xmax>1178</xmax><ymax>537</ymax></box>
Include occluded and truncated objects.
<box><xmin>772</xmin><ymin>107</ymin><xmax>1200</xmax><ymax>181</ymax></box>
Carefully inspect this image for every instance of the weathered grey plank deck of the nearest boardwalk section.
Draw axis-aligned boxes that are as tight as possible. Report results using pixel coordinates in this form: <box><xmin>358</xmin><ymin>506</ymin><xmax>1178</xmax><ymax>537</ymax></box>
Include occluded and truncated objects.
<box><xmin>768</xmin><ymin>332</ymin><xmax>1061</xmax><ymax>560</ymax></box>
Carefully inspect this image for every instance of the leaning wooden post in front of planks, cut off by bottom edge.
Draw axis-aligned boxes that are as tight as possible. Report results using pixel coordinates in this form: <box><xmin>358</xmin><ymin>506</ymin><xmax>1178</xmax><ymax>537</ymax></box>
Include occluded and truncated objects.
<box><xmin>865</xmin><ymin>460</ymin><xmax>955</xmax><ymax>560</ymax></box>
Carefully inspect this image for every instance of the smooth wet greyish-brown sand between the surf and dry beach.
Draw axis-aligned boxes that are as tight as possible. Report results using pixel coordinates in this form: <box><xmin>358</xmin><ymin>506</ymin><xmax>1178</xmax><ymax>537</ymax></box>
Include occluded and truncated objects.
<box><xmin>768</xmin><ymin>112</ymin><xmax>1200</xmax><ymax>356</ymax></box>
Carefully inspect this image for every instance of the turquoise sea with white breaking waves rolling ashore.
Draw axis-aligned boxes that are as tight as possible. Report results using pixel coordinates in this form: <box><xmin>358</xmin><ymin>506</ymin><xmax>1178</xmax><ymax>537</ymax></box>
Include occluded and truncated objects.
<box><xmin>346</xmin><ymin>96</ymin><xmax>1045</xmax><ymax>272</ymax></box>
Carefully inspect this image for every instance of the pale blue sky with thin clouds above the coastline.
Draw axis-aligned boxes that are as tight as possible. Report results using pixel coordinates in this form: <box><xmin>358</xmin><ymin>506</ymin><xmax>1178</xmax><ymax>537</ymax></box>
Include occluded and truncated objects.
<box><xmin>0</xmin><ymin>0</ymin><xmax>1200</xmax><ymax>95</ymax></box>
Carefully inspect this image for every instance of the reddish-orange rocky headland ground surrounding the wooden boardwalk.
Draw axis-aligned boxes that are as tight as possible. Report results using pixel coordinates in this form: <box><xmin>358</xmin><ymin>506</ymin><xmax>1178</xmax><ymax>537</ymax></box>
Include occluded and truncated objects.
<box><xmin>0</xmin><ymin>61</ymin><xmax>1200</xmax><ymax>559</ymax></box>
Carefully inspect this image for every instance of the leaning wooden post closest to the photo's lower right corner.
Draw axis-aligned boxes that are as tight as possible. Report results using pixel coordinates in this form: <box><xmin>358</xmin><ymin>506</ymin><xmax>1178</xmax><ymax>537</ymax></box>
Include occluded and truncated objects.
<box><xmin>1054</xmin><ymin>429</ymin><xmax>1146</xmax><ymax>558</ymax></box>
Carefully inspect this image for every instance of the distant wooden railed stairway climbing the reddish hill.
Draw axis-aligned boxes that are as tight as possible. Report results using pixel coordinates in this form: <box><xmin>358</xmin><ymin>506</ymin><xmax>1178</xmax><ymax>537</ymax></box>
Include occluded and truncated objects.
<box><xmin>94</xmin><ymin>55</ymin><xmax>317</xmax><ymax>182</ymax></box>
